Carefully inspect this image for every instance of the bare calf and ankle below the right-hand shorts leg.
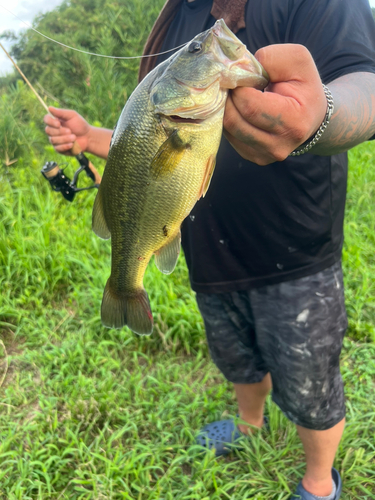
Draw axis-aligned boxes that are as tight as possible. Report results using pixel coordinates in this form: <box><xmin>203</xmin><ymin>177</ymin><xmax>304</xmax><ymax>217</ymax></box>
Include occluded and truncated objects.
<box><xmin>297</xmin><ymin>418</ymin><xmax>345</xmax><ymax>497</ymax></box>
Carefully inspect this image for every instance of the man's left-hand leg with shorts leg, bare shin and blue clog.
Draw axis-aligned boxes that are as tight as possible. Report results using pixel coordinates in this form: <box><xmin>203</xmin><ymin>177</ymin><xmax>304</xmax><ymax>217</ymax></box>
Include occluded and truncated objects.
<box><xmin>197</xmin><ymin>292</ymin><xmax>271</xmax><ymax>456</ymax></box>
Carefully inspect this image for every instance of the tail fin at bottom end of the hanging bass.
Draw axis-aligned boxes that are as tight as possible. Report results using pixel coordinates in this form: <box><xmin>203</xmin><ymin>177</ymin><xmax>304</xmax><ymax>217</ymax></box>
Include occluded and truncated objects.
<box><xmin>101</xmin><ymin>280</ymin><xmax>154</xmax><ymax>335</ymax></box>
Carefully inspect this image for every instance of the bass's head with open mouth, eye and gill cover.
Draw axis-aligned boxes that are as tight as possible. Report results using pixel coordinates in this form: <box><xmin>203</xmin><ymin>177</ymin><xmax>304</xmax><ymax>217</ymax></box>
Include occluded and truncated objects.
<box><xmin>150</xmin><ymin>19</ymin><xmax>269</xmax><ymax>120</ymax></box>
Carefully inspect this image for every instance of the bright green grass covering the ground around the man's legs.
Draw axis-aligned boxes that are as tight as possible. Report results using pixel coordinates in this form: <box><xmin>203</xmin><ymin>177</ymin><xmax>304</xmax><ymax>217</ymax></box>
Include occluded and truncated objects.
<box><xmin>0</xmin><ymin>144</ymin><xmax>375</xmax><ymax>500</ymax></box>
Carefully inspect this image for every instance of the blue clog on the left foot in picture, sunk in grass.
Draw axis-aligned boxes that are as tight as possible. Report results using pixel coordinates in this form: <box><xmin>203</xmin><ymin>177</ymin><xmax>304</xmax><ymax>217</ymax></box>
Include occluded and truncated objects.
<box><xmin>197</xmin><ymin>418</ymin><xmax>268</xmax><ymax>457</ymax></box>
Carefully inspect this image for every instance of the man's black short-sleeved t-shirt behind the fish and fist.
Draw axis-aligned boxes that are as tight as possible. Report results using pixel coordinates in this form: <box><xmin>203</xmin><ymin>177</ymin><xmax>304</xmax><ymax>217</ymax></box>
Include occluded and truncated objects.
<box><xmin>158</xmin><ymin>0</ymin><xmax>375</xmax><ymax>293</ymax></box>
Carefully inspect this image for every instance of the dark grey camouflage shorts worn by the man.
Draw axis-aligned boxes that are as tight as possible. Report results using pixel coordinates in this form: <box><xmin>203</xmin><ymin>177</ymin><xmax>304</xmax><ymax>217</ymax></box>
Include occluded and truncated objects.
<box><xmin>197</xmin><ymin>262</ymin><xmax>347</xmax><ymax>430</ymax></box>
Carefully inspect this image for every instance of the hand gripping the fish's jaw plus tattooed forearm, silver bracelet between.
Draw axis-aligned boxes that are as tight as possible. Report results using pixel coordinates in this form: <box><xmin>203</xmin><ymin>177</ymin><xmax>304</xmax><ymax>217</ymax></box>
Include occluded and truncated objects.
<box><xmin>224</xmin><ymin>44</ymin><xmax>375</xmax><ymax>165</ymax></box>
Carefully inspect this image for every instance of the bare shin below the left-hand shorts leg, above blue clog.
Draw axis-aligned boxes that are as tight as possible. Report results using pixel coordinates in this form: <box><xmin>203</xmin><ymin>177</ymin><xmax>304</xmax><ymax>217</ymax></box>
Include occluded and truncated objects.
<box><xmin>234</xmin><ymin>373</ymin><xmax>272</xmax><ymax>434</ymax></box>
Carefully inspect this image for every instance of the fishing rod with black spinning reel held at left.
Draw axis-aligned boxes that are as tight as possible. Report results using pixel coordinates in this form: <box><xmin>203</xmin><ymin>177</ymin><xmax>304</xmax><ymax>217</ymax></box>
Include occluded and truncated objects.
<box><xmin>0</xmin><ymin>43</ymin><xmax>101</xmax><ymax>201</ymax></box>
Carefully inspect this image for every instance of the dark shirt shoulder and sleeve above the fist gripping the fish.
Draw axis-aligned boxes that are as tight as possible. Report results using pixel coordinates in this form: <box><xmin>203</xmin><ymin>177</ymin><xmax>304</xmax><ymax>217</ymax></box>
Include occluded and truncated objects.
<box><xmin>246</xmin><ymin>0</ymin><xmax>375</xmax><ymax>84</ymax></box>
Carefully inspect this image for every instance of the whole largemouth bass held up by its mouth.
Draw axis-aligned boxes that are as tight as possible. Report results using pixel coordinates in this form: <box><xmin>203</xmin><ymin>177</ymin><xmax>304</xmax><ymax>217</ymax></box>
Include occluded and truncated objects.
<box><xmin>93</xmin><ymin>20</ymin><xmax>268</xmax><ymax>334</ymax></box>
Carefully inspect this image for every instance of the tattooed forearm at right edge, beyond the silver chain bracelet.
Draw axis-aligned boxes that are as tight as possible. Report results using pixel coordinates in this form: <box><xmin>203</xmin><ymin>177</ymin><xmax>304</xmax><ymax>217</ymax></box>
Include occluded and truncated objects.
<box><xmin>310</xmin><ymin>73</ymin><xmax>375</xmax><ymax>156</ymax></box>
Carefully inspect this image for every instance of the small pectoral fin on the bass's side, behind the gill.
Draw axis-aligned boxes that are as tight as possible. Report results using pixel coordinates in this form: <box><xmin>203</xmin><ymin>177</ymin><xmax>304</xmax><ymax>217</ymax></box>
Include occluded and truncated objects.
<box><xmin>150</xmin><ymin>130</ymin><xmax>189</xmax><ymax>179</ymax></box>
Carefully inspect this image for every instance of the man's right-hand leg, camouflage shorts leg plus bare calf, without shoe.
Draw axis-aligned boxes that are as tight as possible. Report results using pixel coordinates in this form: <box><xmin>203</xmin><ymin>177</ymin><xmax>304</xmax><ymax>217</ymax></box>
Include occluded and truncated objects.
<box><xmin>250</xmin><ymin>263</ymin><xmax>347</xmax><ymax>497</ymax></box>
